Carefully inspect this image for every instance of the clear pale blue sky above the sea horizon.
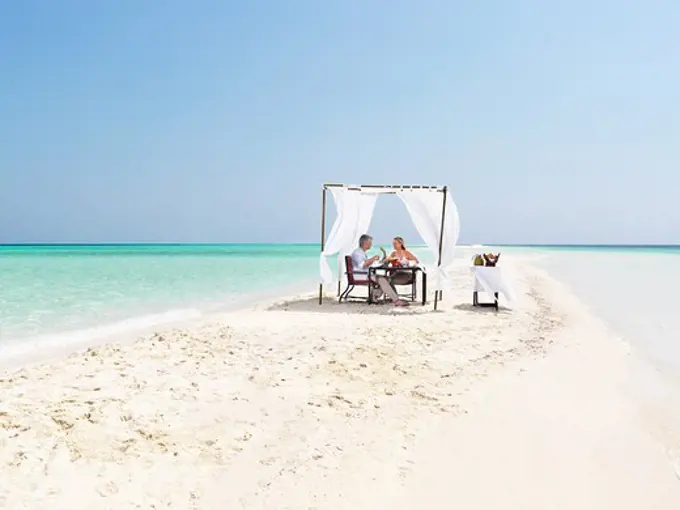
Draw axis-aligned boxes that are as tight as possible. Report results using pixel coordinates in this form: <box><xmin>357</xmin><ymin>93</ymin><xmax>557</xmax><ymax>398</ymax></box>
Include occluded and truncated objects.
<box><xmin>0</xmin><ymin>0</ymin><xmax>680</xmax><ymax>243</ymax></box>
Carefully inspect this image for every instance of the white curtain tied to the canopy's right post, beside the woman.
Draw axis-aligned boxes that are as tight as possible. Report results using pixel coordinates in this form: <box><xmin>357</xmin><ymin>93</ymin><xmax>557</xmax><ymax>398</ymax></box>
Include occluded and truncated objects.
<box><xmin>397</xmin><ymin>189</ymin><xmax>460</xmax><ymax>290</ymax></box>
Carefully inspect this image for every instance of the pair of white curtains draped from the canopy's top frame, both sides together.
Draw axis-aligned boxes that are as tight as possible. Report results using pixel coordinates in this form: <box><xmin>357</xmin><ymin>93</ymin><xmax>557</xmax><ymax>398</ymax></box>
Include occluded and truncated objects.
<box><xmin>320</xmin><ymin>185</ymin><xmax>460</xmax><ymax>306</ymax></box>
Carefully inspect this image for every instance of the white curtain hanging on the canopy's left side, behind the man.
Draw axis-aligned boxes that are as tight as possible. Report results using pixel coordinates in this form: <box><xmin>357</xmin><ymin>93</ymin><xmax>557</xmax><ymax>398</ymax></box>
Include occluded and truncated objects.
<box><xmin>319</xmin><ymin>188</ymin><xmax>377</xmax><ymax>283</ymax></box>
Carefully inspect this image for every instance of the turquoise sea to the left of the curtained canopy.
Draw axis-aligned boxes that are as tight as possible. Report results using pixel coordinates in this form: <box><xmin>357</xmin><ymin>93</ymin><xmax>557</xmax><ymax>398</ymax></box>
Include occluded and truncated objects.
<box><xmin>0</xmin><ymin>244</ymin><xmax>319</xmax><ymax>347</ymax></box>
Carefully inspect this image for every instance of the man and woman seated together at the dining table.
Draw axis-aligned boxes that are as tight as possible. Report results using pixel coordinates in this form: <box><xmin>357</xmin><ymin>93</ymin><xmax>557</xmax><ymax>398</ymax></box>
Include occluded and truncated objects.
<box><xmin>352</xmin><ymin>234</ymin><xmax>418</xmax><ymax>306</ymax></box>
